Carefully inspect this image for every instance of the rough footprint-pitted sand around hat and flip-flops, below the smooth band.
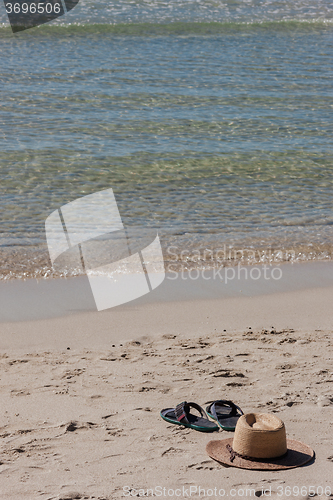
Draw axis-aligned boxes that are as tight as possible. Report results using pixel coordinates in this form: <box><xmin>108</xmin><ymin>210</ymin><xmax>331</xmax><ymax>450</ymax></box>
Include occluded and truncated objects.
<box><xmin>0</xmin><ymin>325</ymin><xmax>333</xmax><ymax>500</ymax></box>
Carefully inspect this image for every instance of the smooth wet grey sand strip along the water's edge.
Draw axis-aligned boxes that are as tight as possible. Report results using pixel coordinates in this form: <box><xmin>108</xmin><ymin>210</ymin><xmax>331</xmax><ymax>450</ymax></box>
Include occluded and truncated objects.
<box><xmin>0</xmin><ymin>261</ymin><xmax>333</xmax><ymax>324</ymax></box>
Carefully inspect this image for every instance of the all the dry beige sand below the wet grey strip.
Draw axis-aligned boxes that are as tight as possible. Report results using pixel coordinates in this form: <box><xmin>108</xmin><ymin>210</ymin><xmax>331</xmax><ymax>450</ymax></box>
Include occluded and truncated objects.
<box><xmin>0</xmin><ymin>264</ymin><xmax>333</xmax><ymax>500</ymax></box>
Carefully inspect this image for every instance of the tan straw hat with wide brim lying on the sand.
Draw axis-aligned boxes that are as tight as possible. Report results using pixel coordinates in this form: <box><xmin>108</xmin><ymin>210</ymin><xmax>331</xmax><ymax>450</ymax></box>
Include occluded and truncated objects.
<box><xmin>206</xmin><ymin>413</ymin><xmax>314</xmax><ymax>470</ymax></box>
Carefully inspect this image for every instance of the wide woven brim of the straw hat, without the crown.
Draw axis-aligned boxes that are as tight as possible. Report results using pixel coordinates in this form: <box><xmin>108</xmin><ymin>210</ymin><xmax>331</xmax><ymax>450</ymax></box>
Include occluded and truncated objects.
<box><xmin>206</xmin><ymin>438</ymin><xmax>315</xmax><ymax>470</ymax></box>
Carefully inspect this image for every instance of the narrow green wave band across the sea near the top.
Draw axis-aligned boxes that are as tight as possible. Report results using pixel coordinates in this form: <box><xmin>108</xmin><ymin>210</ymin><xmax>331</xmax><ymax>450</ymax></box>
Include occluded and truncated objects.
<box><xmin>0</xmin><ymin>19</ymin><xmax>333</xmax><ymax>37</ymax></box>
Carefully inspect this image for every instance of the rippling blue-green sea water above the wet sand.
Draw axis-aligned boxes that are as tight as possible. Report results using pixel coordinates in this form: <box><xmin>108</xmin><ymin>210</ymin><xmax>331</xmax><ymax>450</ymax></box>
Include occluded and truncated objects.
<box><xmin>0</xmin><ymin>0</ymin><xmax>333</xmax><ymax>278</ymax></box>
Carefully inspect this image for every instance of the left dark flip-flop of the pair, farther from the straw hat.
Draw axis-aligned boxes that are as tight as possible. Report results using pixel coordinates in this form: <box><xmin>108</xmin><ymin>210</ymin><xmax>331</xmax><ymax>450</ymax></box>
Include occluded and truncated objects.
<box><xmin>160</xmin><ymin>401</ymin><xmax>219</xmax><ymax>432</ymax></box>
